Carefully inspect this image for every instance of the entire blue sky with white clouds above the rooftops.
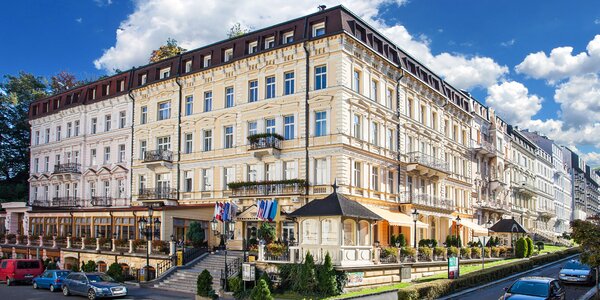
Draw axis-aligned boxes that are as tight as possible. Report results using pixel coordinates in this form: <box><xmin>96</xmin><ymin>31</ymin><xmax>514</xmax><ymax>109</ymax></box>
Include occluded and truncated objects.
<box><xmin>0</xmin><ymin>0</ymin><xmax>600</xmax><ymax>165</ymax></box>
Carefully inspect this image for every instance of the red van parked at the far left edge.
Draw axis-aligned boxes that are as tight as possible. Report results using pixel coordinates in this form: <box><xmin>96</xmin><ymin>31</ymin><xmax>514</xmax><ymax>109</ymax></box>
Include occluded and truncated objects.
<box><xmin>0</xmin><ymin>259</ymin><xmax>44</xmax><ymax>286</ymax></box>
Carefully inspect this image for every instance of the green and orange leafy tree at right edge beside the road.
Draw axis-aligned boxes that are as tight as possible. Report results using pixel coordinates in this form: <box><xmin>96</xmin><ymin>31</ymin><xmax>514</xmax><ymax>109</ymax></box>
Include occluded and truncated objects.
<box><xmin>571</xmin><ymin>220</ymin><xmax>600</xmax><ymax>292</ymax></box>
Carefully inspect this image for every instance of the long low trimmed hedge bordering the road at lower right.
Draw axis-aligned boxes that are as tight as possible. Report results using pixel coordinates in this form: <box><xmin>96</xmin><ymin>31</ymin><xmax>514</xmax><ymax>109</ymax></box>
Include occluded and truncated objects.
<box><xmin>398</xmin><ymin>248</ymin><xmax>581</xmax><ymax>300</ymax></box>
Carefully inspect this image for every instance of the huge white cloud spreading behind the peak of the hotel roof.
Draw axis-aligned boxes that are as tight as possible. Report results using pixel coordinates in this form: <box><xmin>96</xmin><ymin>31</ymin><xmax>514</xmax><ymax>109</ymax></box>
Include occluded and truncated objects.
<box><xmin>94</xmin><ymin>0</ymin><xmax>508</xmax><ymax>89</ymax></box>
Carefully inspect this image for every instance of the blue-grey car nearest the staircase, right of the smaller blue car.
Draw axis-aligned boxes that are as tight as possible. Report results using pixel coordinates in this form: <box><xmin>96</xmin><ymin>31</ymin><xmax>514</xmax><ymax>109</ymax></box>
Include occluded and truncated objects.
<box><xmin>62</xmin><ymin>272</ymin><xmax>127</xmax><ymax>300</ymax></box>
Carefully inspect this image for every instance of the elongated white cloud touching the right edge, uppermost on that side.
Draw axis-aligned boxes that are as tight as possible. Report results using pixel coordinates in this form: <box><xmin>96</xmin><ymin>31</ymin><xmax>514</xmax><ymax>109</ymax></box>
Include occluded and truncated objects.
<box><xmin>515</xmin><ymin>35</ymin><xmax>600</xmax><ymax>84</ymax></box>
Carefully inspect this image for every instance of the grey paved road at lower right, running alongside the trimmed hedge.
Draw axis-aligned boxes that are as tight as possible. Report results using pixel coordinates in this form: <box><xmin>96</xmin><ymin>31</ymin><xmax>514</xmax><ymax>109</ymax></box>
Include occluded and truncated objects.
<box><xmin>452</xmin><ymin>262</ymin><xmax>592</xmax><ymax>300</ymax></box>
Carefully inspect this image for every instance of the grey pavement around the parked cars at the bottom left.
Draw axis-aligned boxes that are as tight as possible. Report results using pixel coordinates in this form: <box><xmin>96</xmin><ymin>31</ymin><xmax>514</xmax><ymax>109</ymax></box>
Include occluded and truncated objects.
<box><xmin>0</xmin><ymin>283</ymin><xmax>194</xmax><ymax>300</ymax></box>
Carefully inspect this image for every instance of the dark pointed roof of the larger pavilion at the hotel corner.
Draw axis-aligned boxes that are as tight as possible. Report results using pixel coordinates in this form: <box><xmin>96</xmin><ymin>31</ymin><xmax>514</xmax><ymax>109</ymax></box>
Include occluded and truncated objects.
<box><xmin>288</xmin><ymin>189</ymin><xmax>382</xmax><ymax>220</ymax></box>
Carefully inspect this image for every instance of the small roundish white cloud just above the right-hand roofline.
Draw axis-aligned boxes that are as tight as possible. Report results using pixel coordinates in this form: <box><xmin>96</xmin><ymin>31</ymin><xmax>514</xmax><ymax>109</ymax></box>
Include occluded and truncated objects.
<box><xmin>485</xmin><ymin>81</ymin><xmax>542</xmax><ymax>126</ymax></box>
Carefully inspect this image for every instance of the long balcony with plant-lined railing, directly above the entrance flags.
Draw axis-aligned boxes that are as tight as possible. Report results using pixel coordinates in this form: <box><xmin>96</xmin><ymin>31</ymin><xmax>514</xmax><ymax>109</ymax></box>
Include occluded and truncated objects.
<box><xmin>228</xmin><ymin>179</ymin><xmax>306</xmax><ymax>197</ymax></box>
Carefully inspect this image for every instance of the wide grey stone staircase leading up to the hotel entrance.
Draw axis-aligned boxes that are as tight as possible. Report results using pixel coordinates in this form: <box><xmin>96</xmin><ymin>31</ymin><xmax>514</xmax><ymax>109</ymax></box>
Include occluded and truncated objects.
<box><xmin>152</xmin><ymin>251</ymin><xmax>243</xmax><ymax>294</ymax></box>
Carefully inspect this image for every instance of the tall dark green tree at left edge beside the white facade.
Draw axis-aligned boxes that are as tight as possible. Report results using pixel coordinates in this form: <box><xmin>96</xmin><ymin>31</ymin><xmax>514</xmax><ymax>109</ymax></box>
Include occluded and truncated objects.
<box><xmin>0</xmin><ymin>72</ymin><xmax>47</xmax><ymax>188</ymax></box>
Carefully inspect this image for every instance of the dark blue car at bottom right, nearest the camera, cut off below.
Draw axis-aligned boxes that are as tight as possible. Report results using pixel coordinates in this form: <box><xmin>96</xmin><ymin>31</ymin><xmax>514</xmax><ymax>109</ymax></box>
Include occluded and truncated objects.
<box><xmin>501</xmin><ymin>277</ymin><xmax>565</xmax><ymax>300</ymax></box>
